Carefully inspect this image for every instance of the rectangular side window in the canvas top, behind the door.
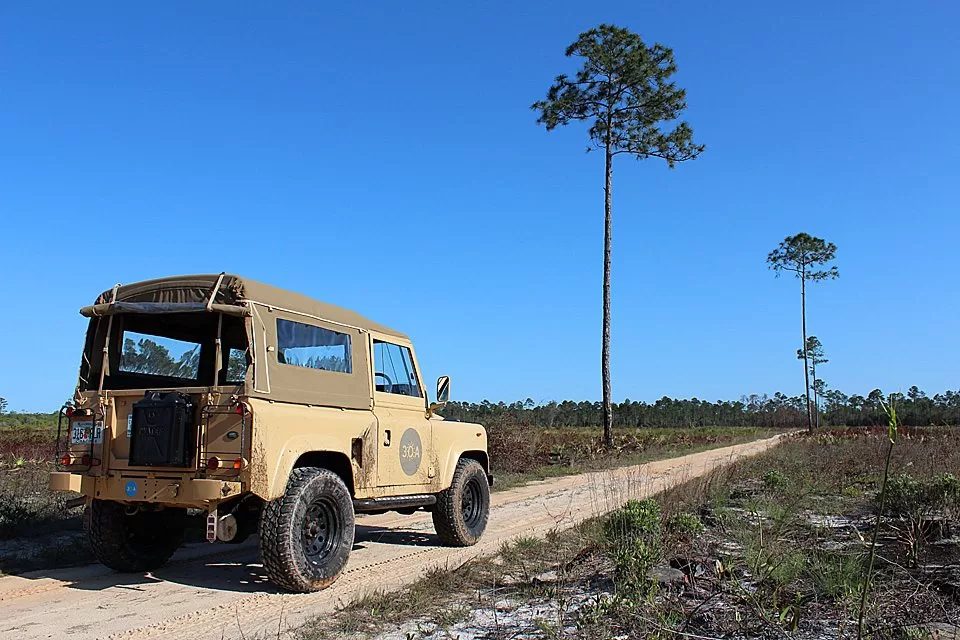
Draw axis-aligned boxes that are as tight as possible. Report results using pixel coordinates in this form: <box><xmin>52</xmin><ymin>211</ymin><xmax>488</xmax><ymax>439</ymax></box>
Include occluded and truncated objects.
<box><xmin>277</xmin><ymin>318</ymin><xmax>353</xmax><ymax>373</ymax></box>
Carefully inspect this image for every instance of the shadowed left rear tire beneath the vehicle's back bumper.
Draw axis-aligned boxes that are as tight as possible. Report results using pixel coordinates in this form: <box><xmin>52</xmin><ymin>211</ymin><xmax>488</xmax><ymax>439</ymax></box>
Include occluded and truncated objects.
<box><xmin>83</xmin><ymin>500</ymin><xmax>187</xmax><ymax>573</ymax></box>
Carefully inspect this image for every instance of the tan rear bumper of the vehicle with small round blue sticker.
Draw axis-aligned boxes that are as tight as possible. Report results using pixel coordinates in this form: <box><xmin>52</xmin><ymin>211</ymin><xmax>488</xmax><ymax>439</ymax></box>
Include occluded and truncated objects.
<box><xmin>50</xmin><ymin>471</ymin><xmax>243</xmax><ymax>505</ymax></box>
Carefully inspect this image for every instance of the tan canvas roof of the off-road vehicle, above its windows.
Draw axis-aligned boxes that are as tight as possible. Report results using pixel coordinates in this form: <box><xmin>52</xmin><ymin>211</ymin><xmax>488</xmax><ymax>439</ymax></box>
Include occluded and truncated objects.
<box><xmin>95</xmin><ymin>274</ymin><xmax>408</xmax><ymax>340</ymax></box>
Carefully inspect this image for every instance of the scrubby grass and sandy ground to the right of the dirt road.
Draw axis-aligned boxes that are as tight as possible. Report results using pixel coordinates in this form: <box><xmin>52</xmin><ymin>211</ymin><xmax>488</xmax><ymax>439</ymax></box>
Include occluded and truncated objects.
<box><xmin>297</xmin><ymin>428</ymin><xmax>960</xmax><ymax>640</ymax></box>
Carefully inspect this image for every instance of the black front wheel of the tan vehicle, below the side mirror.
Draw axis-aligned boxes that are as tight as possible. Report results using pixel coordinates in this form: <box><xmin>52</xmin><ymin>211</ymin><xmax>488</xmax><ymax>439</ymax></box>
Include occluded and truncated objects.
<box><xmin>433</xmin><ymin>458</ymin><xmax>490</xmax><ymax>547</ymax></box>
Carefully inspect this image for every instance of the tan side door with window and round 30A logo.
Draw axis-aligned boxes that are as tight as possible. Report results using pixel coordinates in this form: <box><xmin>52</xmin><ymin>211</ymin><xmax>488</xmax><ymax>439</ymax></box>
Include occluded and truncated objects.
<box><xmin>372</xmin><ymin>337</ymin><xmax>435</xmax><ymax>486</ymax></box>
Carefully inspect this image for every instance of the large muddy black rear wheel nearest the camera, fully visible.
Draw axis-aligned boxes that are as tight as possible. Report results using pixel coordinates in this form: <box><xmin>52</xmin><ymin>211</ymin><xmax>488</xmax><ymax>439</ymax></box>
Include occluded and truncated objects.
<box><xmin>260</xmin><ymin>467</ymin><xmax>354</xmax><ymax>593</ymax></box>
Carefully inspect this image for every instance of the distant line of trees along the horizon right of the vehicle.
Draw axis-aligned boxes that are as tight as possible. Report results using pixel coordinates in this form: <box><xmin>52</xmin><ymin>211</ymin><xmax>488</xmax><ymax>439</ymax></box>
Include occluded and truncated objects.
<box><xmin>441</xmin><ymin>386</ymin><xmax>960</xmax><ymax>429</ymax></box>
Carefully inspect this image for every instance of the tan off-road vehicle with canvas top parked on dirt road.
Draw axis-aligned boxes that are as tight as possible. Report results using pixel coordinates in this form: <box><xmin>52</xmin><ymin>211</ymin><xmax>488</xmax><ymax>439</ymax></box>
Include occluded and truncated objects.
<box><xmin>50</xmin><ymin>274</ymin><xmax>493</xmax><ymax>592</ymax></box>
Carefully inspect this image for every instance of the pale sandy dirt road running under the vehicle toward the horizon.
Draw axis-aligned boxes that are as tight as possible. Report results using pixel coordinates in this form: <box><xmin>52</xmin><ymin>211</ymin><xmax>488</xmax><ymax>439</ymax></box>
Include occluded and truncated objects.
<box><xmin>0</xmin><ymin>438</ymin><xmax>777</xmax><ymax>640</ymax></box>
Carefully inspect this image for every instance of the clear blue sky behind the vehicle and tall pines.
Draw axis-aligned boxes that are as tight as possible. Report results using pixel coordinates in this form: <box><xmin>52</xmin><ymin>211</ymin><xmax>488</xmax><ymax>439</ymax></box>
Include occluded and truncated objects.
<box><xmin>0</xmin><ymin>1</ymin><xmax>960</xmax><ymax>410</ymax></box>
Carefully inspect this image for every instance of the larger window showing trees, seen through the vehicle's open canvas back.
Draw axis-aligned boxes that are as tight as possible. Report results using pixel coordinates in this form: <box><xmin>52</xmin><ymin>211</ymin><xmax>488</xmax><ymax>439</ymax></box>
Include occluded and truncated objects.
<box><xmin>120</xmin><ymin>331</ymin><xmax>200</xmax><ymax>380</ymax></box>
